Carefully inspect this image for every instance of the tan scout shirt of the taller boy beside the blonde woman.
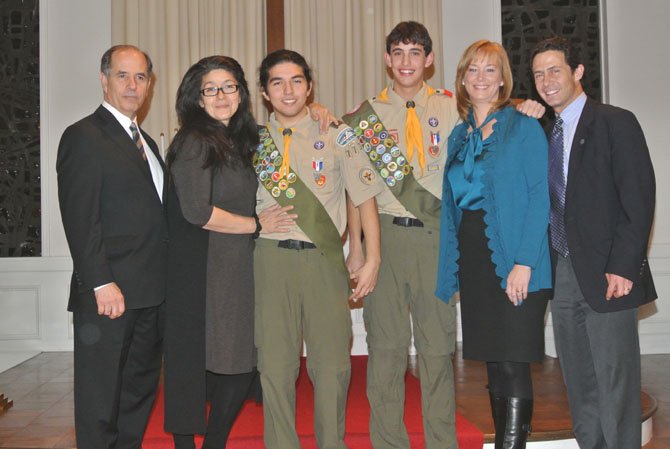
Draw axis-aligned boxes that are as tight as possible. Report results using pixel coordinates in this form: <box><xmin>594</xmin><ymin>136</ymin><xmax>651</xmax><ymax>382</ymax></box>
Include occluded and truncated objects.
<box><xmin>370</xmin><ymin>83</ymin><xmax>459</xmax><ymax>218</ymax></box>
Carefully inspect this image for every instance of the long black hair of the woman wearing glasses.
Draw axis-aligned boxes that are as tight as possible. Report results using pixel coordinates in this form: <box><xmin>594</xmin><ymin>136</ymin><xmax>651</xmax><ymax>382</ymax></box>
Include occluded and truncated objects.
<box><xmin>167</xmin><ymin>55</ymin><xmax>258</xmax><ymax>168</ymax></box>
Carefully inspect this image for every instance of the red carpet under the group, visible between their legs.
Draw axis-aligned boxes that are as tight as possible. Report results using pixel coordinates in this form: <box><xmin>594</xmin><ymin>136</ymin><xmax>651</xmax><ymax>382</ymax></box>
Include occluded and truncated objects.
<box><xmin>142</xmin><ymin>356</ymin><xmax>483</xmax><ymax>449</ymax></box>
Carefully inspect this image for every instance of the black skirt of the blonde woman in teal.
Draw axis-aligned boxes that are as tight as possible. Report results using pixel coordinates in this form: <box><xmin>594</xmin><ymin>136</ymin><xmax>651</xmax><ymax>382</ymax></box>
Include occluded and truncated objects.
<box><xmin>458</xmin><ymin>209</ymin><xmax>549</xmax><ymax>362</ymax></box>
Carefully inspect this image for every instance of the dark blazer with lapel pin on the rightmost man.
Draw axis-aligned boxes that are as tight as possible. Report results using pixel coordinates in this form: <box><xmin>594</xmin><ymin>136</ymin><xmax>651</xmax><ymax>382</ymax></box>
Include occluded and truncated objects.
<box><xmin>554</xmin><ymin>99</ymin><xmax>657</xmax><ymax>312</ymax></box>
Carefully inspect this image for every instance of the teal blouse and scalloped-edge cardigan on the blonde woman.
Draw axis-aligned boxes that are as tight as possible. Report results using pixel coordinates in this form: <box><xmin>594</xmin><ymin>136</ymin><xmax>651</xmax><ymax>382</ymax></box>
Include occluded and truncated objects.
<box><xmin>436</xmin><ymin>107</ymin><xmax>551</xmax><ymax>302</ymax></box>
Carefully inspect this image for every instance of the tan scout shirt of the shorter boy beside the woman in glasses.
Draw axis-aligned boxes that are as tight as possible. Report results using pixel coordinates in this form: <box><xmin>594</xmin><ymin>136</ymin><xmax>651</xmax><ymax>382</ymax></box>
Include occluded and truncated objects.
<box><xmin>256</xmin><ymin>109</ymin><xmax>384</xmax><ymax>242</ymax></box>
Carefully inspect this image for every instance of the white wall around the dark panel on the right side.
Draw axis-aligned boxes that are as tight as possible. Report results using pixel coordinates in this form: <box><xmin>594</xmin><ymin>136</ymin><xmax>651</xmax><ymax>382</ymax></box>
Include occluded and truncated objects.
<box><xmin>436</xmin><ymin>0</ymin><xmax>670</xmax><ymax>355</ymax></box>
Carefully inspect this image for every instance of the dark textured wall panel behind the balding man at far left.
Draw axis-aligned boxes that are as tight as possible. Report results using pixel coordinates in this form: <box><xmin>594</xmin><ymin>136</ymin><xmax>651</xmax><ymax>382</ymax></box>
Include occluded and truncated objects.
<box><xmin>0</xmin><ymin>0</ymin><xmax>41</xmax><ymax>257</ymax></box>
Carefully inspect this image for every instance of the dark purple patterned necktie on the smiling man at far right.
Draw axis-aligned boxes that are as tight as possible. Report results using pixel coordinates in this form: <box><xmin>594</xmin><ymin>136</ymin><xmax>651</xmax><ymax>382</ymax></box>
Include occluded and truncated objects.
<box><xmin>549</xmin><ymin>114</ymin><xmax>568</xmax><ymax>257</ymax></box>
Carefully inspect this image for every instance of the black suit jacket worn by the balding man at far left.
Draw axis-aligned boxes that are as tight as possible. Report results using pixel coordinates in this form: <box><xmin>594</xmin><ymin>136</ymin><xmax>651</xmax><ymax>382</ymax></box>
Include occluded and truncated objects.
<box><xmin>56</xmin><ymin>106</ymin><xmax>167</xmax><ymax>312</ymax></box>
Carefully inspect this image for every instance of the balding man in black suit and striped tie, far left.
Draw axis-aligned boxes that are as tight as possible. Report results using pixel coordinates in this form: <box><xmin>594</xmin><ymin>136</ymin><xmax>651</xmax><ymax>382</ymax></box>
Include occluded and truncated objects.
<box><xmin>56</xmin><ymin>45</ymin><xmax>167</xmax><ymax>449</ymax></box>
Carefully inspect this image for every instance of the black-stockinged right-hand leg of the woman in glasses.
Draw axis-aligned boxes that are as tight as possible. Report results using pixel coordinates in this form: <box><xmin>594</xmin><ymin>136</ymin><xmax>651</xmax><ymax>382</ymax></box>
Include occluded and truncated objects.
<box><xmin>202</xmin><ymin>370</ymin><xmax>257</xmax><ymax>449</ymax></box>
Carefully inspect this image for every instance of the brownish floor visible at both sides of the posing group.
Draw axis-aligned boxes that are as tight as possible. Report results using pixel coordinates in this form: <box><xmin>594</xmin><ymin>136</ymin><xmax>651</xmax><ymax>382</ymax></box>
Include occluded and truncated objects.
<box><xmin>0</xmin><ymin>352</ymin><xmax>670</xmax><ymax>449</ymax></box>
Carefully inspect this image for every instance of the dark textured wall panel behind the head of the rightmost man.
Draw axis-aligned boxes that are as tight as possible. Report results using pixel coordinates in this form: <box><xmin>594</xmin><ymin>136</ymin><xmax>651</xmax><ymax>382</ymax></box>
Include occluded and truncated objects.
<box><xmin>501</xmin><ymin>0</ymin><xmax>602</xmax><ymax>106</ymax></box>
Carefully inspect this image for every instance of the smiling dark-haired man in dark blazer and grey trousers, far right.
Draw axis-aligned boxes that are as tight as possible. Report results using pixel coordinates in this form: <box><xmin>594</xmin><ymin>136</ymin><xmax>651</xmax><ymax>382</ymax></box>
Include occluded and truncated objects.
<box><xmin>531</xmin><ymin>37</ymin><xmax>656</xmax><ymax>449</ymax></box>
